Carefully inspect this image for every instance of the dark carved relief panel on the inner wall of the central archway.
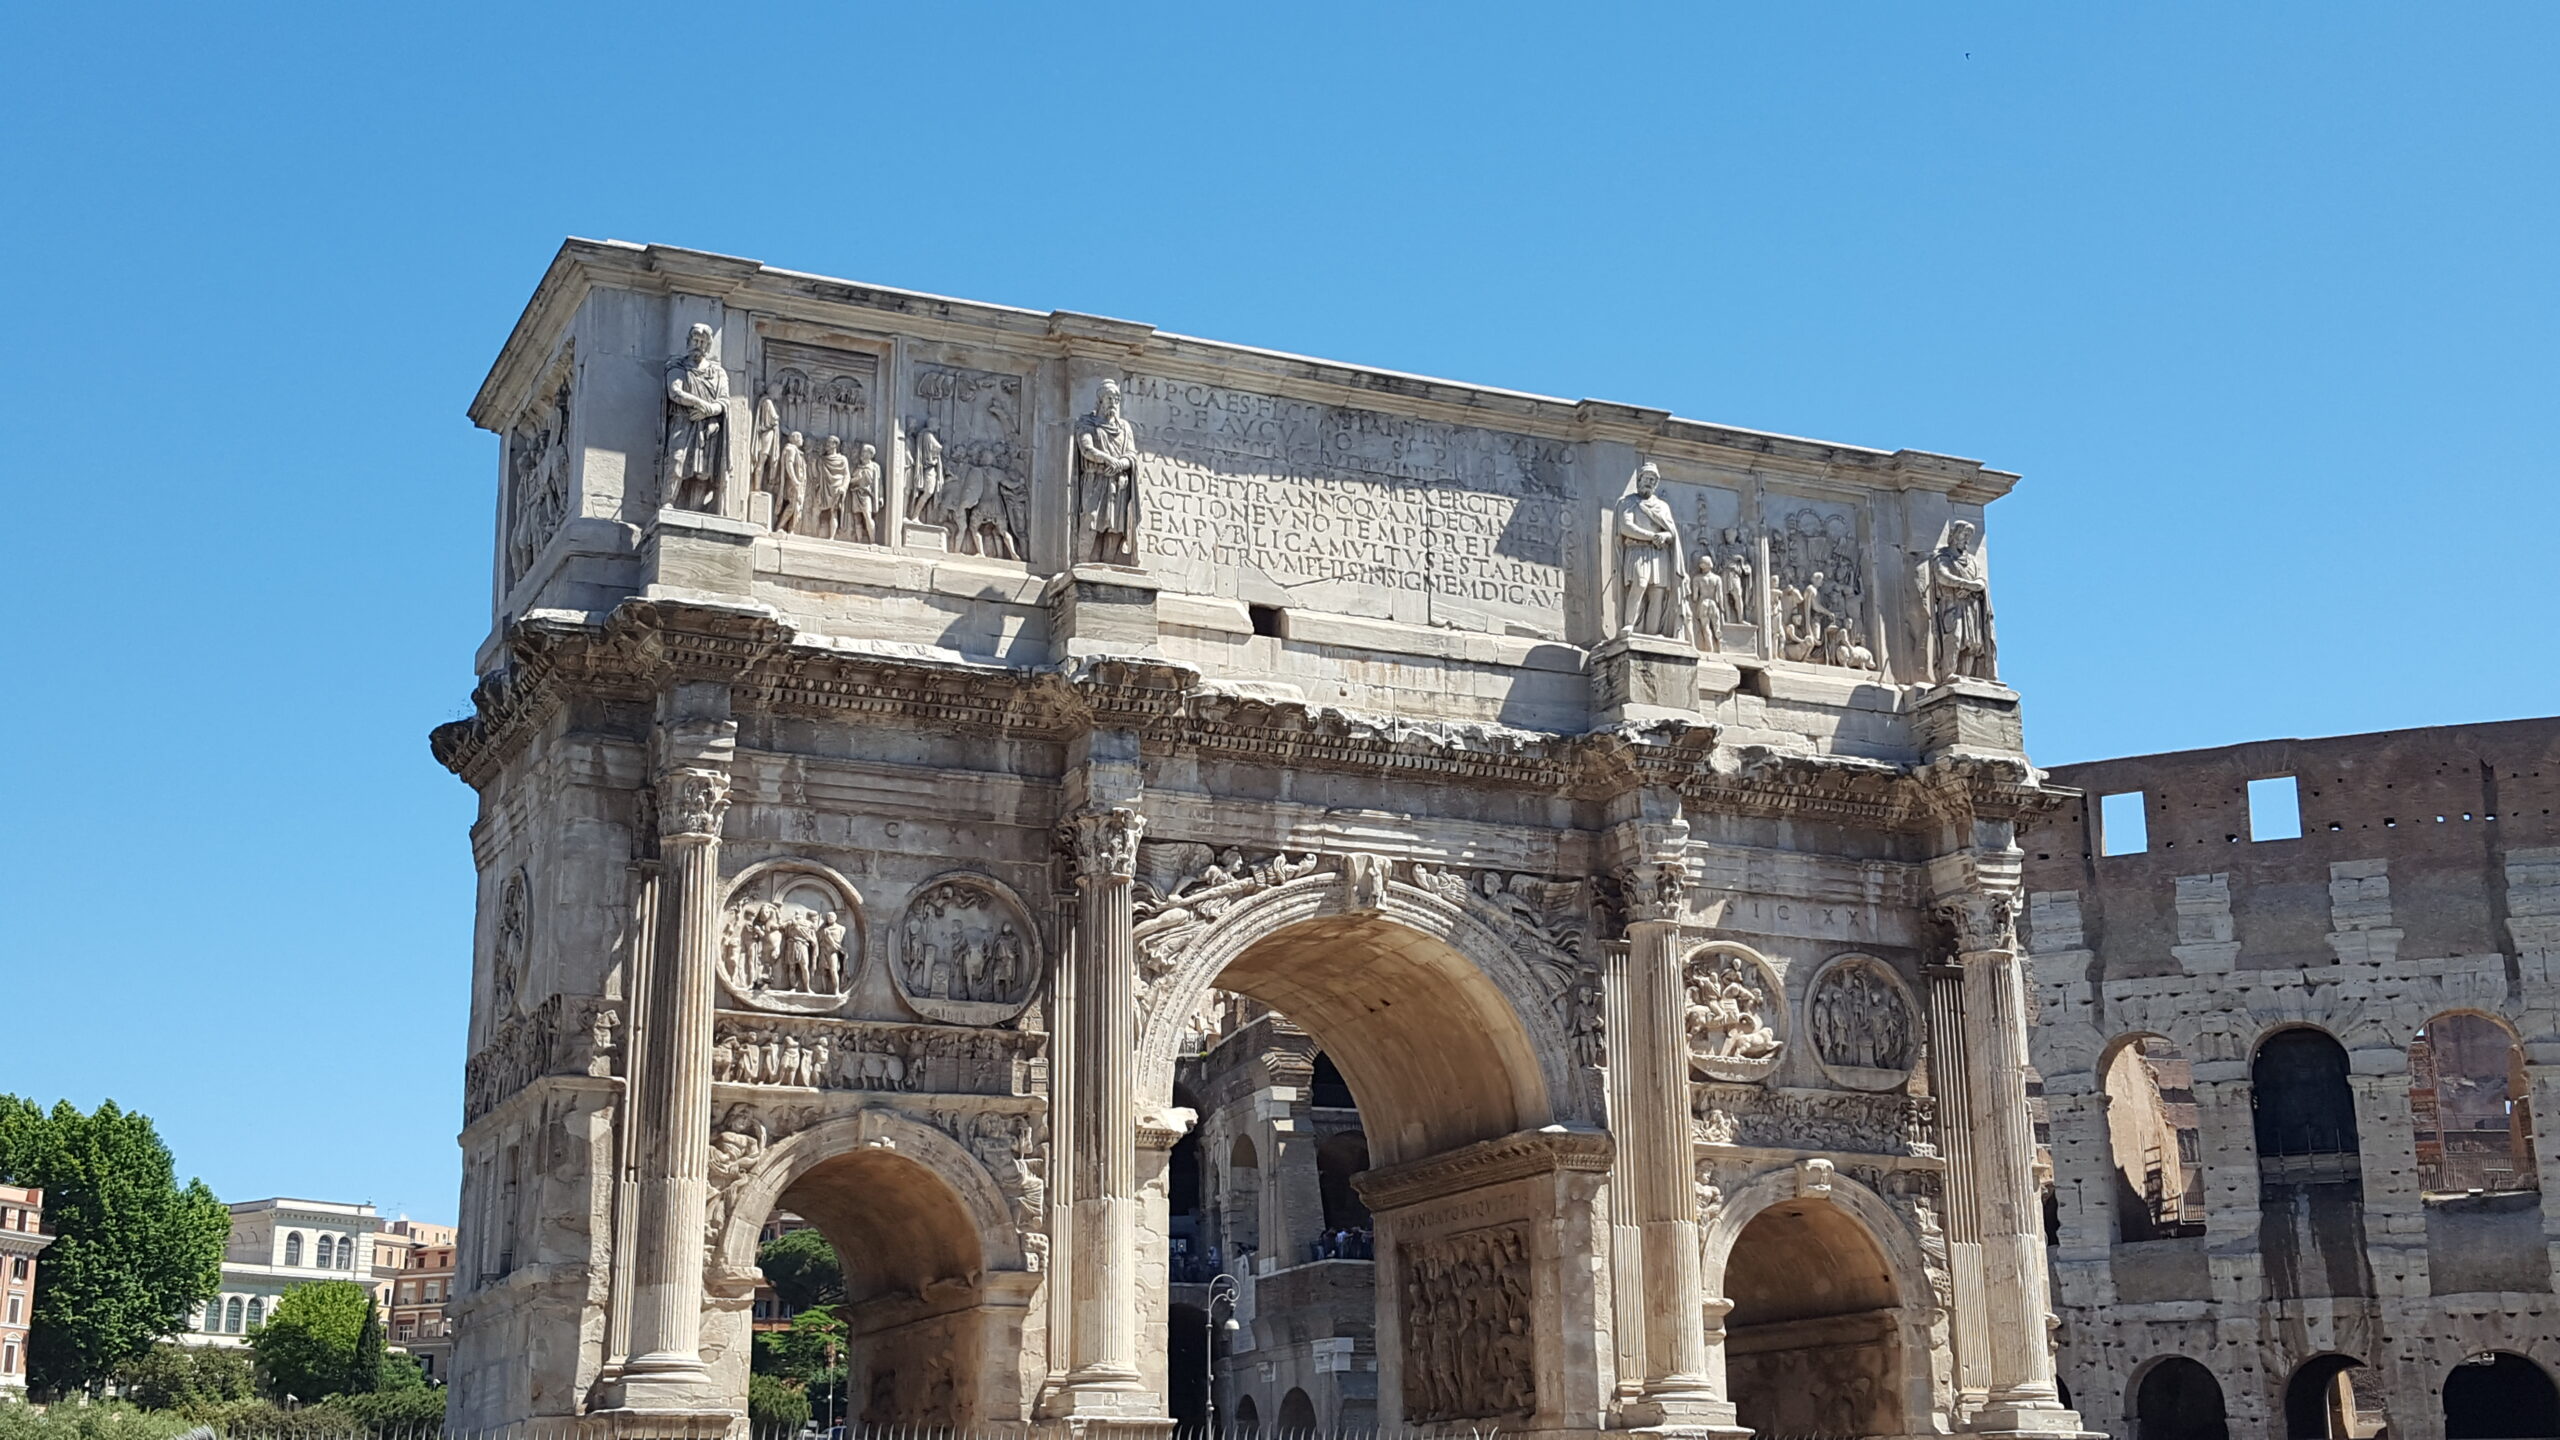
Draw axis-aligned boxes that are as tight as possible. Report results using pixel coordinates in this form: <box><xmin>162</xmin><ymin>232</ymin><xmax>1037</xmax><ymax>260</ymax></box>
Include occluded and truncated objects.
<box><xmin>1395</xmin><ymin>1225</ymin><xmax>1539</xmax><ymax>1425</ymax></box>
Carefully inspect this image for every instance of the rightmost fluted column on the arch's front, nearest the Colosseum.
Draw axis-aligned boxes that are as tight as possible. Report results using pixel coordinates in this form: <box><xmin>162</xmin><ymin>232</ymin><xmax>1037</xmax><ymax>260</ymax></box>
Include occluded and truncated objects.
<box><xmin>1940</xmin><ymin>889</ymin><xmax>2079</xmax><ymax>1432</ymax></box>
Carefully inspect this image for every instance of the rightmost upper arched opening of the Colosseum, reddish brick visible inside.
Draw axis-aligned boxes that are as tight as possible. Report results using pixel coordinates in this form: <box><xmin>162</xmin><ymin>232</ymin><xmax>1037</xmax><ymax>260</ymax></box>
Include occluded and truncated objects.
<box><xmin>2409</xmin><ymin>1010</ymin><xmax>2540</xmax><ymax>1197</ymax></box>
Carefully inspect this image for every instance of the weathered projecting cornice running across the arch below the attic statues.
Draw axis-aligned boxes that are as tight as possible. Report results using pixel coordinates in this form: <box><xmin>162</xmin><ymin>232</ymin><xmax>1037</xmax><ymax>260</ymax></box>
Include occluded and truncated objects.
<box><xmin>430</xmin><ymin>600</ymin><xmax>2063</xmax><ymax>830</ymax></box>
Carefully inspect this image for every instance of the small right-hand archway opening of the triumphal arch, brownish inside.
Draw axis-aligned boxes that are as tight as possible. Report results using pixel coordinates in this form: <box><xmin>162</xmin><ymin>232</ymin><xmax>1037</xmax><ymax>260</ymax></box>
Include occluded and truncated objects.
<box><xmin>1725</xmin><ymin>1199</ymin><xmax>1915</xmax><ymax>1435</ymax></box>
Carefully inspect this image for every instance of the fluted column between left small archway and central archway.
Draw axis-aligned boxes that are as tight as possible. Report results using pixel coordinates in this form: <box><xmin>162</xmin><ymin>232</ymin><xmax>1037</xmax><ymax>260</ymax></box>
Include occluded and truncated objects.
<box><xmin>1060</xmin><ymin>805</ymin><xmax>1147</xmax><ymax>1404</ymax></box>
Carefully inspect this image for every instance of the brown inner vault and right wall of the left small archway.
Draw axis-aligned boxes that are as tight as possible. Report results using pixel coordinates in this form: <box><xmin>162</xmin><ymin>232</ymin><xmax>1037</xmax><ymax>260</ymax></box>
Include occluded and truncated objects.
<box><xmin>752</xmin><ymin>1145</ymin><xmax>1021</xmax><ymax>1425</ymax></box>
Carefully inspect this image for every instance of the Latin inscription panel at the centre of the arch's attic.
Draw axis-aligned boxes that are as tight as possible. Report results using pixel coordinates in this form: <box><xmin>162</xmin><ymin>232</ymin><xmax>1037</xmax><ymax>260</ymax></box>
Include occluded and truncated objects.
<box><xmin>1126</xmin><ymin>374</ymin><xmax>1572</xmax><ymax>623</ymax></box>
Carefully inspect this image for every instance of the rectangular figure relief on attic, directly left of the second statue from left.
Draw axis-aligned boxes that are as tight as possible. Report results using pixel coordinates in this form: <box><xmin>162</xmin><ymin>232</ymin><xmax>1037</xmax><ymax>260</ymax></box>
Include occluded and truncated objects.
<box><xmin>906</xmin><ymin>364</ymin><xmax>1032</xmax><ymax>561</ymax></box>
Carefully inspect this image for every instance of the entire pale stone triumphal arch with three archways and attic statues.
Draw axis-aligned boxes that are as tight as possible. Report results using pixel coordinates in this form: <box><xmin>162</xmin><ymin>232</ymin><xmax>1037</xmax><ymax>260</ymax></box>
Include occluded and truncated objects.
<box><xmin>435</xmin><ymin>241</ymin><xmax>2079</xmax><ymax>1437</ymax></box>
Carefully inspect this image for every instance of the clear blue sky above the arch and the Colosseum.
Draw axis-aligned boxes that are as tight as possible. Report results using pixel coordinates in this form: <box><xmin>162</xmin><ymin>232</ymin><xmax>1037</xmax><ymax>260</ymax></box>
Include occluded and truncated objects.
<box><xmin>0</xmin><ymin>3</ymin><xmax>2560</xmax><ymax>1220</ymax></box>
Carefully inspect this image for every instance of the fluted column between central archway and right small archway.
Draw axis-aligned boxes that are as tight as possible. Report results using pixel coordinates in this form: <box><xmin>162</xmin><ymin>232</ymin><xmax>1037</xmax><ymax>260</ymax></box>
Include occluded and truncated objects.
<box><xmin>1610</xmin><ymin>794</ymin><xmax>1715</xmax><ymax>1425</ymax></box>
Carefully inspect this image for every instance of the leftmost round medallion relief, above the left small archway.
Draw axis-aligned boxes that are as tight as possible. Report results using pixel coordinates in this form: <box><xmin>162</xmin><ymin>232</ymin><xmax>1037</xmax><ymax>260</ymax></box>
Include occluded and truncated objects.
<box><xmin>719</xmin><ymin>861</ymin><xmax>863</xmax><ymax>1015</ymax></box>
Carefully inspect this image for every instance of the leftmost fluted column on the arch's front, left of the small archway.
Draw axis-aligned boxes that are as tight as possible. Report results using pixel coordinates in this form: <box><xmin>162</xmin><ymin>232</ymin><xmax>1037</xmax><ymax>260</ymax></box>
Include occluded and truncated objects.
<box><xmin>614</xmin><ymin>697</ymin><xmax>737</xmax><ymax>1409</ymax></box>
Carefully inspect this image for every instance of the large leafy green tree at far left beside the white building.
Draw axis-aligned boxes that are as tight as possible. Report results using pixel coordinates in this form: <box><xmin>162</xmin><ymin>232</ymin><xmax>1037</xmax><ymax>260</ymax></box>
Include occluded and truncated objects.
<box><xmin>0</xmin><ymin>1094</ymin><xmax>230</xmax><ymax>1394</ymax></box>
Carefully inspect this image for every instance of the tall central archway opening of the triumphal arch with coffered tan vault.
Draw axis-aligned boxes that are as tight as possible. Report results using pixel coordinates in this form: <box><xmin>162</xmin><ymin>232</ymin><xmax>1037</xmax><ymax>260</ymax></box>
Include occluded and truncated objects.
<box><xmin>1167</xmin><ymin>917</ymin><xmax>1551</xmax><ymax>1432</ymax></box>
